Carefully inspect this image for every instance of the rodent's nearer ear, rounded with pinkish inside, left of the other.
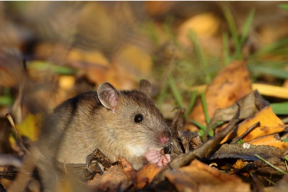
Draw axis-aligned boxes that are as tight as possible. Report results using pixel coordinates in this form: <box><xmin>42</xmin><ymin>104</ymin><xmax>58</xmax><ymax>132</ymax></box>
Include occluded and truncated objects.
<box><xmin>97</xmin><ymin>82</ymin><xmax>119</xmax><ymax>112</ymax></box>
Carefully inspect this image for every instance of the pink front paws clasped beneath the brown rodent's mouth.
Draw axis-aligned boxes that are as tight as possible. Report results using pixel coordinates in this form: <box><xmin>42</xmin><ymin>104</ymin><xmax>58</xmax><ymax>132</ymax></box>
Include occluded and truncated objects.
<box><xmin>144</xmin><ymin>150</ymin><xmax>171</xmax><ymax>167</ymax></box>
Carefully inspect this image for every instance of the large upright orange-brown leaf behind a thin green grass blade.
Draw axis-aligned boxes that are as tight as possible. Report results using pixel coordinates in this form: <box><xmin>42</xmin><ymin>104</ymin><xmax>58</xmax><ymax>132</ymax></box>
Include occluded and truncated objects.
<box><xmin>188</xmin><ymin>61</ymin><xmax>252</xmax><ymax>130</ymax></box>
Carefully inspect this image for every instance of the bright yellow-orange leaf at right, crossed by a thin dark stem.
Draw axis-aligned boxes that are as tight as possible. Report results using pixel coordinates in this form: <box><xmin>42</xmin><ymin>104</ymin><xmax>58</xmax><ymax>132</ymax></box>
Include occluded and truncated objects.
<box><xmin>221</xmin><ymin>106</ymin><xmax>285</xmax><ymax>143</ymax></box>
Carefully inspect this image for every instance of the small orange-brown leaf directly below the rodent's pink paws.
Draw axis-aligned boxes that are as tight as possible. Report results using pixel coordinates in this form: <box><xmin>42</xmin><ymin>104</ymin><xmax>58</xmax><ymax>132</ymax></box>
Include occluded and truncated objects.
<box><xmin>136</xmin><ymin>163</ymin><xmax>162</xmax><ymax>189</ymax></box>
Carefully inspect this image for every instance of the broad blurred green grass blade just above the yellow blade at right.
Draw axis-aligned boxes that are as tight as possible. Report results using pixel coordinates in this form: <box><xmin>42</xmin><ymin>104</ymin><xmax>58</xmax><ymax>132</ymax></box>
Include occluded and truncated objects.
<box><xmin>248</xmin><ymin>65</ymin><xmax>288</xmax><ymax>79</ymax></box>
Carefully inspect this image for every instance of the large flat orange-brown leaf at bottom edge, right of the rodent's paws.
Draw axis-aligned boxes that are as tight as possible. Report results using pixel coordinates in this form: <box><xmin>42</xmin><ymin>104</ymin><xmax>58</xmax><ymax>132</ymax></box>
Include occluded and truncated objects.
<box><xmin>166</xmin><ymin>160</ymin><xmax>250</xmax><ymax>192</ymax></box>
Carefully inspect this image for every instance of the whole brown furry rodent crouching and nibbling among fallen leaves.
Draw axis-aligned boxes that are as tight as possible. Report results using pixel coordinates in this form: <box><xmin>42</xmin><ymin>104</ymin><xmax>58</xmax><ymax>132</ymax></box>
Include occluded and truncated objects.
<box><xmin>40</xmin><ymin>80</ymin><xmax>171</xmax><ymax>169</ymax></box>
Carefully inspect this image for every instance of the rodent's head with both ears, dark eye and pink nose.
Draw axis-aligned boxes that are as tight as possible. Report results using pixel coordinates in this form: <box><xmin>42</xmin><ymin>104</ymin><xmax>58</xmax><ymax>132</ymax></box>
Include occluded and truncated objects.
<box><xmin>97</xmin><ymin>80</ymin><xmax>171</xmax><ymax>152</ymax></box>
